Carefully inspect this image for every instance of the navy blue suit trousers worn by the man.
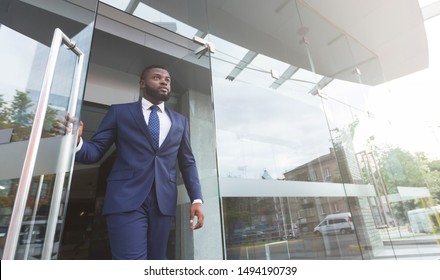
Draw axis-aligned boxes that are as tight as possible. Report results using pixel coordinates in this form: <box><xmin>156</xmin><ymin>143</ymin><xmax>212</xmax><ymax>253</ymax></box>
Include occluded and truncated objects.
<box><xmin>106</xmin><ymin>184</ymin><xmax>172</xmax><ymax>260</ymax></box>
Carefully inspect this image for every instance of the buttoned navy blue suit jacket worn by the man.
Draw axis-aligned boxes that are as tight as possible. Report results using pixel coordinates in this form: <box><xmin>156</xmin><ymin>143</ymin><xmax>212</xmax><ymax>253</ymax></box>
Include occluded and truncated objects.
<box><xmin>75</xmin><ymin>100</ymin><xmax>203</xmax><ymax>215</ymax></box>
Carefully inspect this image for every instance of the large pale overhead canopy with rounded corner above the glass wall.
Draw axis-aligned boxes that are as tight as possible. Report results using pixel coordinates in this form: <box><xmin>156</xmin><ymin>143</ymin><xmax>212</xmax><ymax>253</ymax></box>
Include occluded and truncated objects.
<box><xmin>146</xmin><ymin>0</ymin><xmax>428</xmax><ymax>85</ymax></box>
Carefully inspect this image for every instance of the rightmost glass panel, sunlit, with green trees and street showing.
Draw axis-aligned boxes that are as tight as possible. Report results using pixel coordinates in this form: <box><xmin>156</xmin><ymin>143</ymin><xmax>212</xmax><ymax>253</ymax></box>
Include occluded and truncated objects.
<box><xmin>323</xmin><ymin>70</ymin><xmax>440</xmax><ymax>258</ymax></box>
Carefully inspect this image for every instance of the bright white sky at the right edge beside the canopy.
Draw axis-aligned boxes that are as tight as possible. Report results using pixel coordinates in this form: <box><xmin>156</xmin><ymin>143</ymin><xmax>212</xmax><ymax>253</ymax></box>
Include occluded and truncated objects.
<box><xmin>370</xmin><ymin>12</ymin><xmax>440</xmax><ymax>159</ymax></box>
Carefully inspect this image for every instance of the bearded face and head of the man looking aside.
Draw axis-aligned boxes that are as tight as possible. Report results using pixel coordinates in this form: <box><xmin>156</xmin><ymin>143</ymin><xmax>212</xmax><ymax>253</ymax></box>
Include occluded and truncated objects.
<box><xmin>140</xmin><ymin>68</ymin><xmax>171</xmax><ymax>104</ymax></box>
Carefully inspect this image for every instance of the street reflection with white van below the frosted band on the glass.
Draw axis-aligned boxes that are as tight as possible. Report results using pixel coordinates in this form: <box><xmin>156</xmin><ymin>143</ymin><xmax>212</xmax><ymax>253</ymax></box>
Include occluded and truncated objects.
<box><xmin>223</xmin><ymin>197</ymin><xmax>362</xmax><ymax>260</ymax></box>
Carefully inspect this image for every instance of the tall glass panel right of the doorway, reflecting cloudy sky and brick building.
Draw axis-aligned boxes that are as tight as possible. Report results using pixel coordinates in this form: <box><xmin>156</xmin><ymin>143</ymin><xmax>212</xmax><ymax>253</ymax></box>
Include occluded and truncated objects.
<box><xmin>210</xmin><ymin>31</ymin><xmax>359</xmax><ymax>259</ymax></box>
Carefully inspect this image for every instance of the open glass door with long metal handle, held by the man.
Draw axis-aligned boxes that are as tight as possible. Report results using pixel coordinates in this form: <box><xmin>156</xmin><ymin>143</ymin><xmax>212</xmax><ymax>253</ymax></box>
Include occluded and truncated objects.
<box><xmin>0</xmin><ymin>1</ymin><xmax>96</xmax><ymax>259</ymax></box>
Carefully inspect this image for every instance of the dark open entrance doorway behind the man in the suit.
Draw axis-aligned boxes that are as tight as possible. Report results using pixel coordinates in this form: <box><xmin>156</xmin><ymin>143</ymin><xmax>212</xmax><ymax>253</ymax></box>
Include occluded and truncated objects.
<box><xmin>60</xmin><ymin>3</ymin><xmax>215</xmax><ymax>259</ymax></box>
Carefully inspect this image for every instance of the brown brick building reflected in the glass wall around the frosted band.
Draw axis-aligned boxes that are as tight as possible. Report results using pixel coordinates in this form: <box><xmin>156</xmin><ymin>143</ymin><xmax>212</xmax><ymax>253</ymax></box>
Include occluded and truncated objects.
<box><xmin>284</xmin><ymin>144</ymin><xmax>381</xmax><ymax>258</ymax></box>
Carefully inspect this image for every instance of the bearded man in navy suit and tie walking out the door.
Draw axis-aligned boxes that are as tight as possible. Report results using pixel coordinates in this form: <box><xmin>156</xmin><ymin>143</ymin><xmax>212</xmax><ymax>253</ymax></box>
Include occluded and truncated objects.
<box><xmin>75</xmin><ymin>65</ymin><xmax>204</xmax><ymax>259</ymax></box>
